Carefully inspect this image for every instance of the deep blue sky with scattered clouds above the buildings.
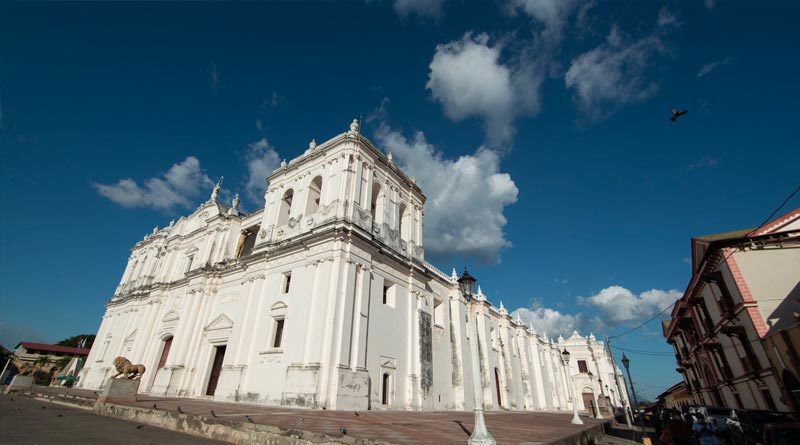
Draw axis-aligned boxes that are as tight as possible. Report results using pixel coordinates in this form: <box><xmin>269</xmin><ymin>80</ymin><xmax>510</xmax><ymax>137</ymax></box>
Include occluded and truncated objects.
<box><xmin>0</xmin><ymin>0</ymin><xmax>800</xmax><ymax>397</ymax></box>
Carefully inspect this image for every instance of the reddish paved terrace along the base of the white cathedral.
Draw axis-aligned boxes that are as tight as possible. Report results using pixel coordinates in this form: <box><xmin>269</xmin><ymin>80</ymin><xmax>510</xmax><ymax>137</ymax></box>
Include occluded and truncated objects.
<box><xmin>21</xmin><ymin>388</ymin><xmax>599</xmax><ymax>445</ymax></box>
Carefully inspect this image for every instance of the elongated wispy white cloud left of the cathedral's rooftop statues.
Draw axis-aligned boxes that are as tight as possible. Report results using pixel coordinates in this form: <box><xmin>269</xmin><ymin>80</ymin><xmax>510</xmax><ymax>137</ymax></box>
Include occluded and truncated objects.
<box><xmin>92</xmin><ymin>156</ymin><xmax>213</xmax><ymax>210</ymax></box>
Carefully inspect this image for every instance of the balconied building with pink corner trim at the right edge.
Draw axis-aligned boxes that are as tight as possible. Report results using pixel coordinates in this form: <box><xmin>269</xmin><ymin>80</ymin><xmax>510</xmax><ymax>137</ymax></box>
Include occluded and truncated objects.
<box><xmin>663</xmin><ymin>209</ymin><xmax>800</xmax><ymax>411</ymax></box>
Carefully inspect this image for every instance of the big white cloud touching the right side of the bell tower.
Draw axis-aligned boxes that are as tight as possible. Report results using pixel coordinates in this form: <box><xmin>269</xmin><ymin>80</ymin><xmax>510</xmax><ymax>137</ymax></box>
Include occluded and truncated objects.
<box><xmin>375</xmin><ymin>114</ymin><xmax>518</xmax><ymax>261</ymax></box>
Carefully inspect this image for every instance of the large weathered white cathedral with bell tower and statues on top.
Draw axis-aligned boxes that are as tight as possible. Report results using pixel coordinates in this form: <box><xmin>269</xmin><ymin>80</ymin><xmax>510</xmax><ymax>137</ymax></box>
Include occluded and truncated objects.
<box><xmin>78</xmin><ymin>121</ymin><xmax>627</xmax><ymax>414</ymax></box>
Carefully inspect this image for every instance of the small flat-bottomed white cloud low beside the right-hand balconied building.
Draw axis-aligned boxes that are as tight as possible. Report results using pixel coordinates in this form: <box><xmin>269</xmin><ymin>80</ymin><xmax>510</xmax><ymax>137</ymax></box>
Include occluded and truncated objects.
<box><xmin>578</xmin><ymin>286</ymin><xmax>683</xmax><ymax>326</ymax></box>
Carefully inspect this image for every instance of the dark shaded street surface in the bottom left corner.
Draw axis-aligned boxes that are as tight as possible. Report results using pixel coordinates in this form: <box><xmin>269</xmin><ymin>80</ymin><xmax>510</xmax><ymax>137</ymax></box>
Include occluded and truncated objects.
<box><xmin>0</xmin><ymin>395</ymin><xmax>222</xmax><ymax>445</ymax></box>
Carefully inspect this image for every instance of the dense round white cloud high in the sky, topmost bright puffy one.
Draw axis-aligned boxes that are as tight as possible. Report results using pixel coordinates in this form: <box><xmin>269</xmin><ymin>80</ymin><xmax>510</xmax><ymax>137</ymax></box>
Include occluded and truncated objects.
<box><xmin>426</xmin><ymin>33</ymin><xmax>543</xmax><ymax>145</ymax></box>
